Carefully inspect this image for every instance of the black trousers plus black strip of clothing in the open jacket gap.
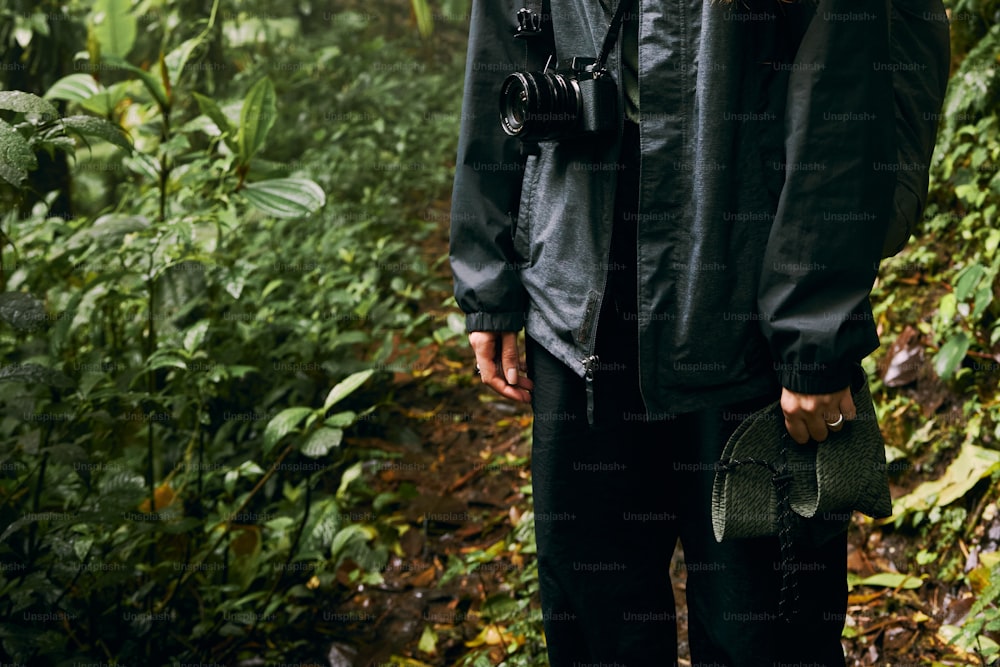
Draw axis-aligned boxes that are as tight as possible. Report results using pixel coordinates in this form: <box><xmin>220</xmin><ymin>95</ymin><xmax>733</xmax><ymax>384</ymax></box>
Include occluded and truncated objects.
<box><xmin>527</xmin><ymin>121</ymin><xmax>847</xmax><ymax>667</ymax></box>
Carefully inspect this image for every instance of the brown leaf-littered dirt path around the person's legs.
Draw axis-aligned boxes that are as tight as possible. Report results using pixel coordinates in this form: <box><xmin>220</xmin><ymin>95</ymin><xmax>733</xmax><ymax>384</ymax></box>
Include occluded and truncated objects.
<box><xmin>316</xmin><ymin>220</ymin><xmax>1000</xmax><ymax>667</ymax></box>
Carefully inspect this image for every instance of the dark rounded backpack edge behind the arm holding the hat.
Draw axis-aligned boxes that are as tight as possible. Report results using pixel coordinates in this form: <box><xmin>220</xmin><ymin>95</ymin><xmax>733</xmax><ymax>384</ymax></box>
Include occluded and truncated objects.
<box><xmin>882</xmin><ymin>0</ymin><xmax>951</xmax><ymax>257</ymax></box>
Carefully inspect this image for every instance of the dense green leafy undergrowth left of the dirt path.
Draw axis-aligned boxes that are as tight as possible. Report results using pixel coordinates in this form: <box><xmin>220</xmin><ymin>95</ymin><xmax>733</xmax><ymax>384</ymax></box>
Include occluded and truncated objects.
<box><xmin>0</xmin><ymin>0</ymin><xmax>460</xmax><ymax>664</ymax></box>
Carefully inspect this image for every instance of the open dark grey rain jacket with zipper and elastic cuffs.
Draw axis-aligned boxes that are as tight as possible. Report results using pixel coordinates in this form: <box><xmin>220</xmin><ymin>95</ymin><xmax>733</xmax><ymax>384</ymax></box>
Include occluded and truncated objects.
<box><xmin>451</xmin><ymin>0</ymin><xmax>949</xmax><ymax>418</ymax></box>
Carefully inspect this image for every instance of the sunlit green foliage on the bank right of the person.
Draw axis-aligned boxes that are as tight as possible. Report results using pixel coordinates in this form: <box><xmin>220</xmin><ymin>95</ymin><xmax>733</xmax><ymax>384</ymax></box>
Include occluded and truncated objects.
<box><xmin>874</xmin><ymin>0</ymin><xmax>1000</xmax><ymax>664</ymax></box>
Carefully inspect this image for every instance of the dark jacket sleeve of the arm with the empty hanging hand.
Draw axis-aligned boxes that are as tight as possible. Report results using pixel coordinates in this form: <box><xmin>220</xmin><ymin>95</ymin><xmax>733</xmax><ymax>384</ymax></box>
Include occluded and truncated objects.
<box><xmin>450</xmin><ymin>0</ymin><xmax>553</xmax><ymax>331</ymax></box>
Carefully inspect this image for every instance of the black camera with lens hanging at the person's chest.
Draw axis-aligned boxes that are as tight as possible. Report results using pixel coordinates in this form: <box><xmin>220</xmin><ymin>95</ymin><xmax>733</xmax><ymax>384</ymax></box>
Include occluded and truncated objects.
<box><xmin>500</xmin><ymin>57</ymin><xmax>618</xmax><ymax>143</ymax></box>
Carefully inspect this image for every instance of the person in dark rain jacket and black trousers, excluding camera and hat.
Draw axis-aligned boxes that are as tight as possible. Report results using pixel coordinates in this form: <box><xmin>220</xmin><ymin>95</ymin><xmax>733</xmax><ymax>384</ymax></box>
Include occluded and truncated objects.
<box><xmin>451</xmin><ymin>0</ymin><xmax>948</xmax><ymax>666</ymax></box>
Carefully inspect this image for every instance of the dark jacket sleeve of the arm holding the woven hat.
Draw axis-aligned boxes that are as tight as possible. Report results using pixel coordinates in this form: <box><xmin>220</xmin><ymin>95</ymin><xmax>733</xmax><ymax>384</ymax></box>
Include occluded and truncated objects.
<box><xmin>758</xmin><ymin>0</ymin><xmax>897</xmax><ymax>394</ymax></box>
